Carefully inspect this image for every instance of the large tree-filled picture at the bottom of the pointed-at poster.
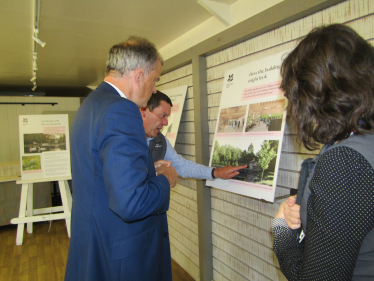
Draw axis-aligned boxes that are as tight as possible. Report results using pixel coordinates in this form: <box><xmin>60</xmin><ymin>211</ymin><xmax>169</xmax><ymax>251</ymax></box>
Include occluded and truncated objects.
<box><xmin>211</xmin><ymin>138</ymin><xmax>279</xmax><ymax>186</ymax></box>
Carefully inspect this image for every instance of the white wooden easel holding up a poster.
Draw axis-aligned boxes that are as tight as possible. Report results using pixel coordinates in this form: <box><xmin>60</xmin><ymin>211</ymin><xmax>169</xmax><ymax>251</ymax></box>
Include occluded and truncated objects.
<box><xmin>10</xmin><ymin>177</ymin><xmax>73</xmax><ymax>245</ymax></box>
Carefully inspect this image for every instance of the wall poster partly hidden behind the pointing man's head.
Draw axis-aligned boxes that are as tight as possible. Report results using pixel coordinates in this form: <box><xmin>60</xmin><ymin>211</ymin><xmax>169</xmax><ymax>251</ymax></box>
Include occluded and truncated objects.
<box><xmin>161</xmin><ymin>86</ymin><xmax>187</xmax><ymax>147</ymax></box>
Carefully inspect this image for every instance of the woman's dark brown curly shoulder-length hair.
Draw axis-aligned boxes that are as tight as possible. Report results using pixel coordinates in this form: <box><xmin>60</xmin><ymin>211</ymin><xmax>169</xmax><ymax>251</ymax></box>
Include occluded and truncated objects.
<box><xmin>281</xmin><ymin>24</ymin><xmax>374</xmax><ymax>150</ymax></box>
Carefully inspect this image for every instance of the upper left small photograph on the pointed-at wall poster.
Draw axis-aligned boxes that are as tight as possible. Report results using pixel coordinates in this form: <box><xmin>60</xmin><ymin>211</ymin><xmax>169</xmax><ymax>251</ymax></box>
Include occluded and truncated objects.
<box><xmin>217</xmin><ymin>105</ymin><xmax>247</xmax><ymax>133</ymax></box>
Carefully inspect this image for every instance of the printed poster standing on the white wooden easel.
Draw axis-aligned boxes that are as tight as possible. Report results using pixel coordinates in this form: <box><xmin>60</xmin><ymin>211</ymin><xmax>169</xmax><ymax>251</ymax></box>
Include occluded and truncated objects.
<box><xmin>19</xmin><ymin>114</ymin><xmax>71</xmax><ymax>180</ymax></box>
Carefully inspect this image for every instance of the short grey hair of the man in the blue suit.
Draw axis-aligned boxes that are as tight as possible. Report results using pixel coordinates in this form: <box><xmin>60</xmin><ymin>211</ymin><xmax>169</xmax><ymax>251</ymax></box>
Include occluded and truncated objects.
<box><xmin>106</xmin><ymin>36</ymin><xmax>163</xmax><ymax>75</ymax></box>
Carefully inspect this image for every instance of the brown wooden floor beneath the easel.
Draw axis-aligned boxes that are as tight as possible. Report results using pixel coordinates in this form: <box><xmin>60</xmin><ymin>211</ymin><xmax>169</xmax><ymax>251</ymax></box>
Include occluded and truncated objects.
<box><xmin>0</xmin><ymin>220</ymin><xmax>194</xmax><ymax>281</ymax></box>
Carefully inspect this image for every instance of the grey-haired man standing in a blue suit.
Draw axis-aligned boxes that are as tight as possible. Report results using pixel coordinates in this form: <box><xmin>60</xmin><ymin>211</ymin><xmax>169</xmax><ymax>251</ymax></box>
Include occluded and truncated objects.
<box><xmin>65</xmin><ymin>37</ymin><xmax>177</xmax><ymax>281</ymax></box>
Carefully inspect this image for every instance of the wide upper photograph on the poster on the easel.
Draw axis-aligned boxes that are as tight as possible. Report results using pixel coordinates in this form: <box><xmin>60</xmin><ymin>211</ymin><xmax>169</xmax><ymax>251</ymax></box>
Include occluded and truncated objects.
<box><xmin>23</xmin><ymin>133</ymin><xmax>66</xmax><ymax>154</ymax></box>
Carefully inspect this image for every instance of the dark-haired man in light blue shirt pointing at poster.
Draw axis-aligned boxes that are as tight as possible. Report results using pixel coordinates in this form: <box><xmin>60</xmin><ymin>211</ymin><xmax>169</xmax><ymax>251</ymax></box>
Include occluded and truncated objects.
<box><xmin>141</xmin><ymin>91</ymin><xmax>246</xmax><ymax>179</ymax></box>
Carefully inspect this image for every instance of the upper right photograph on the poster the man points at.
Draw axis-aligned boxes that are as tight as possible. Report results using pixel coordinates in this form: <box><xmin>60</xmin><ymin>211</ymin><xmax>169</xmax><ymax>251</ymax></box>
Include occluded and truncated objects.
<box><xmin>245</xmin><ymin>99</ymin><xmax>286</xmax><ymax>132</ymax></box>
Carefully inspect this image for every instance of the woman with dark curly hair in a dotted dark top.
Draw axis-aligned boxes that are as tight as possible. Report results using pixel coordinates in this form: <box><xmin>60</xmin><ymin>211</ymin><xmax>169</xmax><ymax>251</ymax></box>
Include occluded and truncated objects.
<box><xmin>272</xmin><ymin>24</ymin><xmax>374</xmax><ymax>281</ymax></box>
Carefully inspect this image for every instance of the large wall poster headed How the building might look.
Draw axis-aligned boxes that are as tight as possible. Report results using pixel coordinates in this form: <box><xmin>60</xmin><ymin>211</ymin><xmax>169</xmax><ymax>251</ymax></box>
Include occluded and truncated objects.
<box><xmin>206</xmin><ymin>51</ymin><xmax>289</xmax><ymax>202</ymax></box>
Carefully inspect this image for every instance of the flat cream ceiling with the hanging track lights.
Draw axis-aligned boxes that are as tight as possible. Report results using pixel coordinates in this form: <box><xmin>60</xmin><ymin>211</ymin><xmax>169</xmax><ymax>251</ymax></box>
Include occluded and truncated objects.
<box><xmin>0</xmin><ymin>0</ymin><xmax>219</xmax><ymax>95</ymax></box>
